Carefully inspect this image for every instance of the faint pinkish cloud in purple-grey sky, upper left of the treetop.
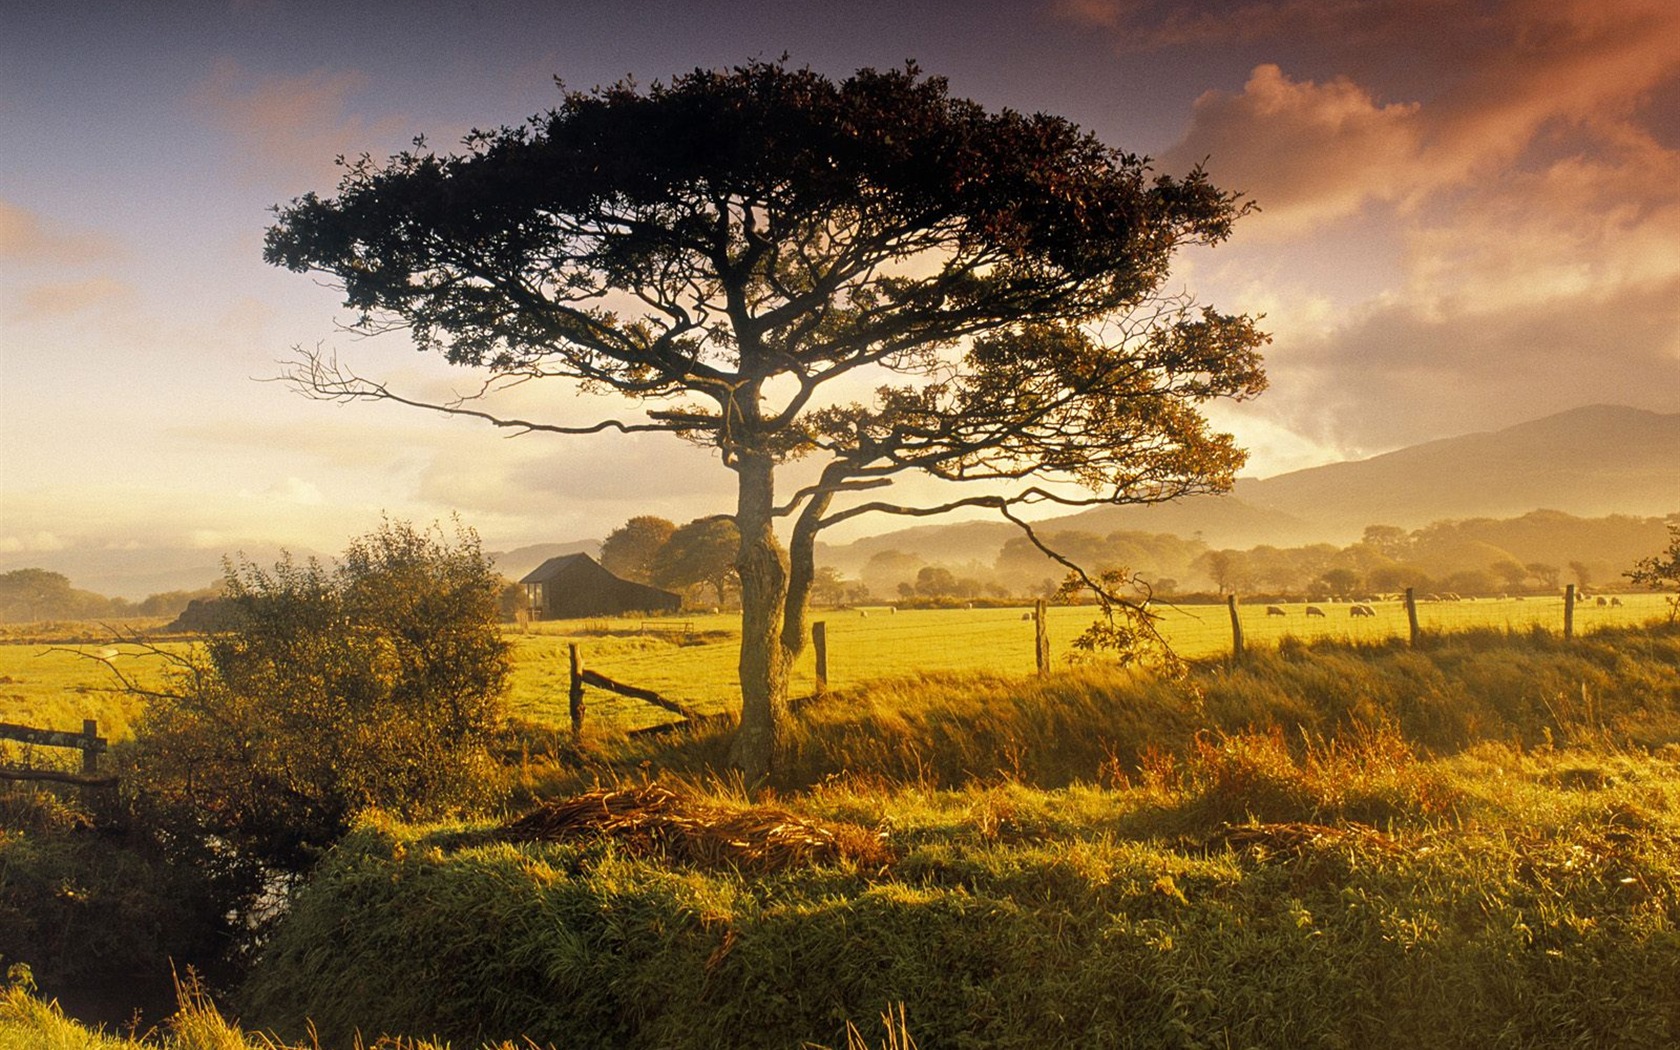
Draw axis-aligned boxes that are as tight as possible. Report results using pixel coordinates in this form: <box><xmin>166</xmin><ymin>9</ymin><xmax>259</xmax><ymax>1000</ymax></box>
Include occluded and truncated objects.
<box><xmin>193</xmin><ymin>59</ymin><xmax>403</xmax><ymax>186</ymax></box>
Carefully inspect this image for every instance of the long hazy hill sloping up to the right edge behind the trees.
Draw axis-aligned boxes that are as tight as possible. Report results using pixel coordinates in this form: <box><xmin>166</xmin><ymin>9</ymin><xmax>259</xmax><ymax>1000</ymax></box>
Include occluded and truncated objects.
<box><xmin>818</xmin><ymin>405</ymin><xmax>1680</xmax><ymax>573</ymax></box>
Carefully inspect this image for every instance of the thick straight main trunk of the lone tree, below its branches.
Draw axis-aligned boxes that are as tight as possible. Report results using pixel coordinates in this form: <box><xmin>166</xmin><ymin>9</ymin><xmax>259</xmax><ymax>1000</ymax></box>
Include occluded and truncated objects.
<box><xmin>729</xmin><ymin>454</ymin><xmax>790</xmax><ymax>783</ymax></box>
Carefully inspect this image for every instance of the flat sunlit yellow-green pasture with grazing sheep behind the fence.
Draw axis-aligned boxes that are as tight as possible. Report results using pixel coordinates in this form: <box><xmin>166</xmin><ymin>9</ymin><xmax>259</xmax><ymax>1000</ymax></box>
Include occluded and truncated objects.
<box><xmin>0</xmin><ymin>595</ymin><xmax>1667</xmax><ymax>739</ymax></box>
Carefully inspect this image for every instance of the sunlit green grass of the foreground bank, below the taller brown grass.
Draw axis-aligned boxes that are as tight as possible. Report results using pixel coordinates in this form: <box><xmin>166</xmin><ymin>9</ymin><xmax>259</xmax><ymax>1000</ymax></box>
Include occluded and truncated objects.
<box><xmin>236</xmin><ymin>734</ymin><xmax>1680</xmax><ymax>1048</ymax></box>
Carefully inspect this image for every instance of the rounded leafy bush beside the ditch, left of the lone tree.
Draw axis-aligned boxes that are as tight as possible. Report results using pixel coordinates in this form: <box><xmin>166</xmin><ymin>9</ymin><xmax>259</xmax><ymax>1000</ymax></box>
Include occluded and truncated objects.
<box><xmin>124</xmin><ymin>521</ymin><xmax>507</xmax><ymax>870</ymax></box>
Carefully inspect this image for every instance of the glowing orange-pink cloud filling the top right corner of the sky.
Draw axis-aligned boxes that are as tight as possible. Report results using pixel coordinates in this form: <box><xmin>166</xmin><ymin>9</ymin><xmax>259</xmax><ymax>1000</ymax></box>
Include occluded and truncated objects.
<box><xmin>1155</xmin><ymin>0</ymin><xmax>1680</xmax><ymax>235</ymax></box>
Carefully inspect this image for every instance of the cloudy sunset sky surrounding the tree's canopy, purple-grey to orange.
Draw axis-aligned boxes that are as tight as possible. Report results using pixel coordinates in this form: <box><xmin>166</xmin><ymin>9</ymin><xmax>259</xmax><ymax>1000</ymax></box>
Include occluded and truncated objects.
<box><xmin>0</xmin><ymin>0</ymin><xmax>1680</xmax><ymax>577</ymax></box>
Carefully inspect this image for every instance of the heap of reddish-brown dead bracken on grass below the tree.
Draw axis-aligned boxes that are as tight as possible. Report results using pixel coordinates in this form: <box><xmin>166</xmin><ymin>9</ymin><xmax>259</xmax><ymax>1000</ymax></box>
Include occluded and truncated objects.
<box><xmin>501</xmin><ymin>785</ymin><xmax>892</xmax><ymax>874</ymax></box>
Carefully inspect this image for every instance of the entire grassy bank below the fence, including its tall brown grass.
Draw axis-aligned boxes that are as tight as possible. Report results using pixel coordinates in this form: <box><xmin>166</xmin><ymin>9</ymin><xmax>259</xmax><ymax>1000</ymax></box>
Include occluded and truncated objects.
<box><xmin>0</xmin><ymin>628</ymin><xmax>1680</xmax><ymax>1048</ymax></box>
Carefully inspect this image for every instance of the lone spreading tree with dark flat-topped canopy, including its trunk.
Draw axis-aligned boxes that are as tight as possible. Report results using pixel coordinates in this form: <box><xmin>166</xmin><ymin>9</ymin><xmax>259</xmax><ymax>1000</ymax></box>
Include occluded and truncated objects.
<box><xmin>265</xmin><ymin>62</ymin><xmax>1265</xmax><ymax>776</ymax></box>
